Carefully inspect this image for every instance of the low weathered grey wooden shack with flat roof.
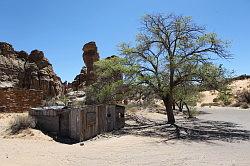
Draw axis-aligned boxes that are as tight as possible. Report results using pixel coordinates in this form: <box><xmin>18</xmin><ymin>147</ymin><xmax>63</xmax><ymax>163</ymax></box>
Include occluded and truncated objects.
<box><xmin>29</xmin><ymin>105</ymin><xmax>125</xmax><ymax>141</ymax></box>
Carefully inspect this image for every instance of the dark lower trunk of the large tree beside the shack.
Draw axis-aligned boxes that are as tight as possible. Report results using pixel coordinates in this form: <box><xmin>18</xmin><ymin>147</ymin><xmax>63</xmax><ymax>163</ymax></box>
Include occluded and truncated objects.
<box><xmin>163</xmin><ymin>95</ymin><xmax>175</xmax><ymax>124</ymax></box>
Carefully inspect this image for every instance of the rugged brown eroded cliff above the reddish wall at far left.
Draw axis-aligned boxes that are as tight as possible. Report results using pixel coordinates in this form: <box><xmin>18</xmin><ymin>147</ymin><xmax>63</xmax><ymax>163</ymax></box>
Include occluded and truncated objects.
<box><xmin>0</xmin><ymin>42</ymin><xmax>64</xmax><ymax>99</ymax></box>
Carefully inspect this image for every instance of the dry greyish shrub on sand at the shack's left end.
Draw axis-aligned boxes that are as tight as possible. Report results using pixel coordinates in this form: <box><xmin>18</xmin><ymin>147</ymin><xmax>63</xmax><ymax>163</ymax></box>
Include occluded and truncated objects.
<box><xmin>7</xmin><ymin>115</ymin><xmax>36</xmax><ymax>134</ymax></box>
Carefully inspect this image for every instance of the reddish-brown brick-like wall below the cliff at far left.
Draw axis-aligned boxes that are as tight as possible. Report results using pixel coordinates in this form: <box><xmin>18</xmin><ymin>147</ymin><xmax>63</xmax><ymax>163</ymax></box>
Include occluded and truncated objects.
<box><xmin>0</xmin><ymin>88</ymin><xmax>43</xmax><ymax>112</ymax></box>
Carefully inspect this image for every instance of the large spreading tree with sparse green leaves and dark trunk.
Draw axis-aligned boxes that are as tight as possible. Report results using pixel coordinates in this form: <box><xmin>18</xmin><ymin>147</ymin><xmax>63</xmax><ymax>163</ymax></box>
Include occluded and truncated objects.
<box><xmin>120</xmin><ymin>14</ymin><xmax>230</xmax><ymax>124</ymax></box>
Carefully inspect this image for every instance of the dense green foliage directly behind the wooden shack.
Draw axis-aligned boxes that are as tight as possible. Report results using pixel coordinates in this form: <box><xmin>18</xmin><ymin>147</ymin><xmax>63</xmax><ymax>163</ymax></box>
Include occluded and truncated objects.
<box><xmin>86</xmin><ymin>56</ymin><xmax>136</xmax><ymax>104</ymax></box>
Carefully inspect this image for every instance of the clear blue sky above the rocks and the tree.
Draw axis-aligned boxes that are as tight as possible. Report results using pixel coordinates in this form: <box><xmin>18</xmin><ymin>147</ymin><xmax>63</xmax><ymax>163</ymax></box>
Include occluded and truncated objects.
<box><xmin>0</xmin><ymin>0</ymin><xmax>250</xmax><ymax>81</ymax></box>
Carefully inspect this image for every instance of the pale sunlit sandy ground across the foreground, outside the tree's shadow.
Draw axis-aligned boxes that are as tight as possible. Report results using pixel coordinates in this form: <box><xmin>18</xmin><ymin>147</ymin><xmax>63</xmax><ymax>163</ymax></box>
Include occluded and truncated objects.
<box><xmin>0</xmin><ymin>107</ymin><xmax>250</xmax><ymax>166</ymax></box>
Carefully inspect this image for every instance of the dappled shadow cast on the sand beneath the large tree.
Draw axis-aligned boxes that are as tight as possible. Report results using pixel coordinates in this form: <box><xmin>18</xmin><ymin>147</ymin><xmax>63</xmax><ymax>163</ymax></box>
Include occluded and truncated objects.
<box><xmin>113</xmin><ymin>115</ymin><xmax>250</xmax><ymax>142</ymax></box>
